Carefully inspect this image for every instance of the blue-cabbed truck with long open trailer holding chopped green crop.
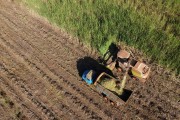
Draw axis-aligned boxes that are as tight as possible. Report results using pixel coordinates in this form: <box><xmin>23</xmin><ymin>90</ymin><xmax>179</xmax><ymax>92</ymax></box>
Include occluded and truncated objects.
<box><xmin>82</xmin><ymin>70</ymin><xmax>132</xmax><ymax>106</ymax></box>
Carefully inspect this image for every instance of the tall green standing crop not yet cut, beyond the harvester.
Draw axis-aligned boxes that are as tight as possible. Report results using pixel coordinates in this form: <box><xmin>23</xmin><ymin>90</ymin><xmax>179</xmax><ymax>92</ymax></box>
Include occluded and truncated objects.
<box><xmin>21</xmin><ymin>0</ymin><xmax>180</xmax><ymax>74</ymax></box>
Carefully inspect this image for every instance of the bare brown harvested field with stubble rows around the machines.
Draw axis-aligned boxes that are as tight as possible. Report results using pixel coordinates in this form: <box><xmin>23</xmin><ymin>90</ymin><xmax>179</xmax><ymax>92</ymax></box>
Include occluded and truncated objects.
<box><xmin>0</xmin><ymin>0</ymin><xmax>180</xmax><ymax>120</ymax></box>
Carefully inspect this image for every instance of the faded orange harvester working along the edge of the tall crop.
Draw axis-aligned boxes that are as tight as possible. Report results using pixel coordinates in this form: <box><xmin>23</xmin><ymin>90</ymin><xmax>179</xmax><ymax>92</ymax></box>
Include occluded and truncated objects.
<box><xmin>104</xmin><ymin>47</ymin><xmax>150</xmax><ymax>83</ymax></box>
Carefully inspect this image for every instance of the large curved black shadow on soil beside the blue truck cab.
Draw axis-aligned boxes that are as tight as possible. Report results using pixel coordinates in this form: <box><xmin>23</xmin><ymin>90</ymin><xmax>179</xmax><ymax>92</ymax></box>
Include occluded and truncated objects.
<box><xmin>77</xmin><ymin>57</ymin><xmax>114</xmax><ymax>77</ymax></box>
